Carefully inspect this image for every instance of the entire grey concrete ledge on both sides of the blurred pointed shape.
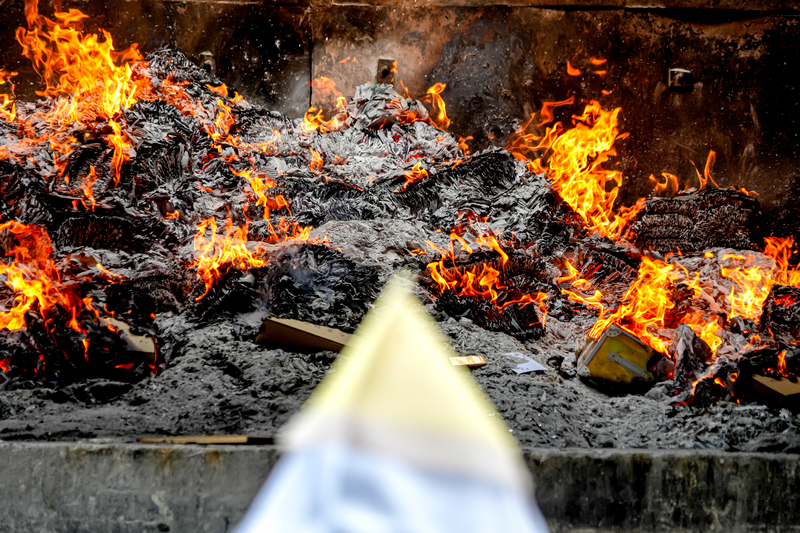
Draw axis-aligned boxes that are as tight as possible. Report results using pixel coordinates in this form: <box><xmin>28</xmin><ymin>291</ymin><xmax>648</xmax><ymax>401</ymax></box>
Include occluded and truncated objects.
<box><xmin>0</xmin><ymin>442</ymin><xmax>800</xmax><ymax>533</ymax></box>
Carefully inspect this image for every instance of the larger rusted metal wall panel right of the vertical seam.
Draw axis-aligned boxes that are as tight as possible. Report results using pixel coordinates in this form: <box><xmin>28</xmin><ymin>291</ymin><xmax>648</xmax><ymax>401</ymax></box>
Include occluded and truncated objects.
<box><xmin>312</xmin><ymin>6</ymin><xmax>800</xmax><ymax>230</ymax></box>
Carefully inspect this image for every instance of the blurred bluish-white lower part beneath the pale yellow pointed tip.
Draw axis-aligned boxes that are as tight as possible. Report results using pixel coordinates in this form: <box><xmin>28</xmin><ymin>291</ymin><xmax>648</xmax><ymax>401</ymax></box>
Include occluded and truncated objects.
<box><xmin>234</xmin><ymin>443</ymin><xmax>548</xmax><ymax>533</ymax></box>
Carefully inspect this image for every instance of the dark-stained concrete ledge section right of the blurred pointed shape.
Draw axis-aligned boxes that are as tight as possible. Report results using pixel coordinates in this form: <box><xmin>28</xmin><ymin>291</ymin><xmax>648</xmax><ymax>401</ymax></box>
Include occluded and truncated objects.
<box><xmin>525</xmin><ymin>449</ymin><xmax>800</xmax><ymax>533</ymax></box>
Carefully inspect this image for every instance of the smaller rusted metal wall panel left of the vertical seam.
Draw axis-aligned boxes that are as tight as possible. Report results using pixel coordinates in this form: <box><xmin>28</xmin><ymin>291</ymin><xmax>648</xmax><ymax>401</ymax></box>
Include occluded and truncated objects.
<box><xmin>0</xmin><ymin>0</ymin><xmax>311</xmax><ymax>116</ymax></box>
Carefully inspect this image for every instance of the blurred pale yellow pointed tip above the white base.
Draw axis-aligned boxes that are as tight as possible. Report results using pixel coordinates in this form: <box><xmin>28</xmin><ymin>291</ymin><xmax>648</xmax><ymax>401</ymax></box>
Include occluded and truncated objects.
<box><xmin>284</xmin><ymin>274</ymin><xmax>521</xmax><ymax>492</ymax></box>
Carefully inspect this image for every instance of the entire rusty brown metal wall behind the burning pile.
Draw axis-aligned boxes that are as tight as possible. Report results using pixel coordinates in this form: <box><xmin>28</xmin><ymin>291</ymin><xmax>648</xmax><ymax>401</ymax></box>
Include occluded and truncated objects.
<box><xmin>0</xmin><ymin>0</ymin><xmax>800</xmax><ymax>232</ymax></box>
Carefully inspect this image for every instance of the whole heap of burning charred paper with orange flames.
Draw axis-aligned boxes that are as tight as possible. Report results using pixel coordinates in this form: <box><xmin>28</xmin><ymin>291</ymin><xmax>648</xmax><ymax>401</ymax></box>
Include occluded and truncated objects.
<box><xmin>0</xmin><ymin>0</ymin><xmax>800</xmax><ymax>432</ymax></box>
